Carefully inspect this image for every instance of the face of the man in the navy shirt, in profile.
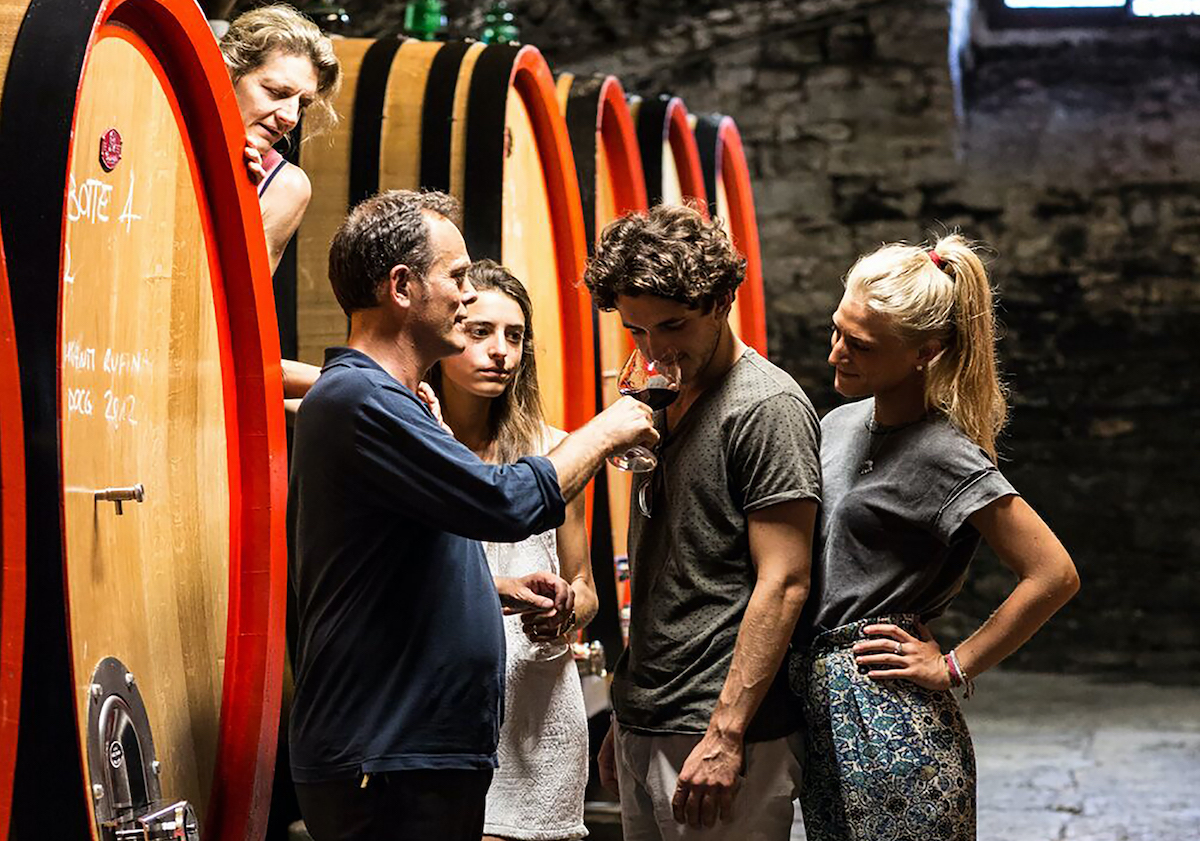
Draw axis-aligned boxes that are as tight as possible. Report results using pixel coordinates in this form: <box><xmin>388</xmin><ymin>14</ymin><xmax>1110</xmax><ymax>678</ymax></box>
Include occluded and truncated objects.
<box><xmin>408</xmin><ymin>211</ymin><xmax>475</xmax><ymax>359</ymax></box>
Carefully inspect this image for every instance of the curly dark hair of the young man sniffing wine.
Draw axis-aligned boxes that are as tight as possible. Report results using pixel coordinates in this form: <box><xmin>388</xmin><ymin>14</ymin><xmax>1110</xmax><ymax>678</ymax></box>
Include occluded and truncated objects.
<box><xmin>583</xmin><ymin>204</ymin><xmax>746</xmax><ymax>313</ymax></box>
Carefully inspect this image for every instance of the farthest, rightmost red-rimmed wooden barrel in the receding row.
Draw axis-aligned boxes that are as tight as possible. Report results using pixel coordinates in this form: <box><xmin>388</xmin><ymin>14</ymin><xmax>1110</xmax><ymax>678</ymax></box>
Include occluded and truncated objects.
<box><xmin>695</xmin><ymin>114</ymin><xmax>767</xmax><ymax>356</ymax></box>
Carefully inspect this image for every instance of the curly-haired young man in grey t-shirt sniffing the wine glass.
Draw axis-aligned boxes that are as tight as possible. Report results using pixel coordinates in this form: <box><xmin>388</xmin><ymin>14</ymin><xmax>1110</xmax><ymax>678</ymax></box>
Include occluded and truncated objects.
<box><xmin>584</xmin><ymin>206</ymin><xmax>821</xmax><ymax>841</ymax></box>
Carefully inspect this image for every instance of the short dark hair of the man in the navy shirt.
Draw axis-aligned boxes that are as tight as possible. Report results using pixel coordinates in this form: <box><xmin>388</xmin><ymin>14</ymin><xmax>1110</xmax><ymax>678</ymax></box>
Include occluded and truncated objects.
<box><xmin>329</xmin><ymin>190</ymin><xmax>461</xmax><ymax>316</ymax></box>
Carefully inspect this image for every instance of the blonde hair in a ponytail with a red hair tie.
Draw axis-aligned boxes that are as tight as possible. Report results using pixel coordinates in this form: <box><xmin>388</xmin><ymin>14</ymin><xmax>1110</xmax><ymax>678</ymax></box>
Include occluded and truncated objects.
<box><xmin>846</xmin><ymin>234</ymin><xmax>1008</xmax><ymax>461</ymax></box>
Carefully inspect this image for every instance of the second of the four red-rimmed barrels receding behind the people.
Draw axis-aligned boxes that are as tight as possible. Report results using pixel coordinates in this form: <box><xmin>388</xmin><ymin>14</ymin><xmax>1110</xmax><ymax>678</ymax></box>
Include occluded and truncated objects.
<box><xmin>558</xmin><ymin>73</ymin><xmax>647</xmax><ymax>657</ymax></box>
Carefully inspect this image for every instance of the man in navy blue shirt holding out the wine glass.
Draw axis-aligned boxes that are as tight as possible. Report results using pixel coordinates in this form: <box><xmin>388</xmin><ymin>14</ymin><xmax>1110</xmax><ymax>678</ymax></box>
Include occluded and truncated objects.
<box><xmin>288</xmin><ymin>191</ymin><xmax>656</xmax><ymax>841</ymax></box>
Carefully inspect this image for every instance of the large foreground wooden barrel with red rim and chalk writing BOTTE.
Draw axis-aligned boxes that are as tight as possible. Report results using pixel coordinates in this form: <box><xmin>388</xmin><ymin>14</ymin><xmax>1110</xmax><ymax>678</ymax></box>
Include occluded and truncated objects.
<box><xmin>0</xmin><ymin>0</ymin><xmax>286</xmax><ymax>841</ymax></box>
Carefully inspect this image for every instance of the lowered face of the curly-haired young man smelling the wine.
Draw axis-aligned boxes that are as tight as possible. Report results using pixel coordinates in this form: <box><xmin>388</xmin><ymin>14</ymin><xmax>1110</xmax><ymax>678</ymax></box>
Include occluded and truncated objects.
<box><xmin>617</xmin><ymin>295</ymin><xmax>730</xmax><ymax>385</ymax></box>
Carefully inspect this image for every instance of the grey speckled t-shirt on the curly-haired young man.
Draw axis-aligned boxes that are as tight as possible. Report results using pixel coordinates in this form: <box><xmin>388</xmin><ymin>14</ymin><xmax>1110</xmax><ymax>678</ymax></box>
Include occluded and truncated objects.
<box><xmin>612</xmin><ymin>349</ymin><xmax>821</xmax><ymax>741</ymax></box>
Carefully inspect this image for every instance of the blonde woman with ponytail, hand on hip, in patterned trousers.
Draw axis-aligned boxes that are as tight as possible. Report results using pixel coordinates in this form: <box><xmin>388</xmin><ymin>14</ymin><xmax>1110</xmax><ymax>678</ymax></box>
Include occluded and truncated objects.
<box><xmin>790</xmin><ymin>235</ymin><xmax>1079</xmax><ymax>841</ymax></box>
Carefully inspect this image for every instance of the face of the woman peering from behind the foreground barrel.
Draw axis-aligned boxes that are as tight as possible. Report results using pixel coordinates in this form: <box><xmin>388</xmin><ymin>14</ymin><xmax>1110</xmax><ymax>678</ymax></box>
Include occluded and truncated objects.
<box><xmin>233</xmin><ymin>50</ymin><xmax>317</xmax><ymax>152</ymax></box>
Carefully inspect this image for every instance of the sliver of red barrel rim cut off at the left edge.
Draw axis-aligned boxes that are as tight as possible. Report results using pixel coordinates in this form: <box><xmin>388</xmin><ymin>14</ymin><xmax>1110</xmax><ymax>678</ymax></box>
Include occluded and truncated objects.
<box><xmin>0</xmin><ymin>242</ymin><xmax>25</xmax><ymax>839</ymax></box>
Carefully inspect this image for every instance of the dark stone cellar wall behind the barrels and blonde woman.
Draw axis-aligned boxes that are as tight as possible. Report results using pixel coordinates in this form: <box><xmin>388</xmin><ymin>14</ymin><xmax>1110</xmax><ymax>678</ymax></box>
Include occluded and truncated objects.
<box><xmin>218</xmin><ymin>0</ymin><xmax>1200</xmax><ymax>683</ymax></box>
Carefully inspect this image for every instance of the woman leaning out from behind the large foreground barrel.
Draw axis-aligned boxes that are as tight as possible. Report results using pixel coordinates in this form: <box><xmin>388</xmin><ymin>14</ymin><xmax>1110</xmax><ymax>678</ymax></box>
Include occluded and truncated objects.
<box><xmin>221</xmin><ymin>4</ymin><xmax>341</xmax><ymax>397</ymax></box>
